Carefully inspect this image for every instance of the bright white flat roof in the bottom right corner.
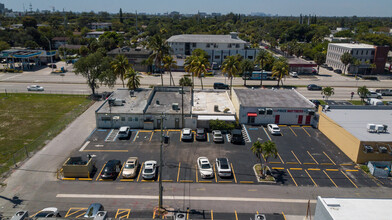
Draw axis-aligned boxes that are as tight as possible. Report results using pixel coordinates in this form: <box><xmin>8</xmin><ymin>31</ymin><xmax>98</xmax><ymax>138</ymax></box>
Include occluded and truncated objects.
<box><xmin>317</xmin><ymin>197</ymin><xmax>392</xmax><ymax>220</ymax></box>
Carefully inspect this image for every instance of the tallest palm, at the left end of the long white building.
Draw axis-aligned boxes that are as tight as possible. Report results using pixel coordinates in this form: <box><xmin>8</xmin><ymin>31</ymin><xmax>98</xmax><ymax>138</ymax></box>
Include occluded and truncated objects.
<box><xmin>147</xmin><ymin>34</ymin><xmax>170</xmax><ymax>86</ymax></box>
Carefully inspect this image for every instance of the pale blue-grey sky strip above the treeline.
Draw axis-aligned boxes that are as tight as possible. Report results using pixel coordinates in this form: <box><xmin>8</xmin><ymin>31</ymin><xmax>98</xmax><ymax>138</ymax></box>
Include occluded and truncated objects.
<box><xmin>0</xmin><ymin>0</ymin><xmax>392</xmax><ymax>17</ymax></box>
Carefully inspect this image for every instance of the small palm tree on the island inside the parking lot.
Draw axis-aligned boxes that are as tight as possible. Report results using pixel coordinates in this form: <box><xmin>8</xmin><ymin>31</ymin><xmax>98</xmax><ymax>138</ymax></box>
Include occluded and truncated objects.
<box><xmin>251</xmin><ymin>141</ymin><xmax>278</xmax><ymax>177</ymax></box>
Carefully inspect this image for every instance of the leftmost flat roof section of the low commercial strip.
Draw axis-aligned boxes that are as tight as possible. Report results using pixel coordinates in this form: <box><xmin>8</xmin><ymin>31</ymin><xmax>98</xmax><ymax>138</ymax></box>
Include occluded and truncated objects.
<box><xmin>97</xmin><ymin>89</ymin><xmax>152</xmax><ymax>114</ymax></box>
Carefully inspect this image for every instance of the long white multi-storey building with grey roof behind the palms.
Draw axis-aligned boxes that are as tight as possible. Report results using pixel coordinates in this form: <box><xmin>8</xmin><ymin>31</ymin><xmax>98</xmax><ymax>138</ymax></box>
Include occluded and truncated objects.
<box><xmin>167</xmin><ymin>32</ymin><xmax>258</xmax><ymax>64</ymax></box>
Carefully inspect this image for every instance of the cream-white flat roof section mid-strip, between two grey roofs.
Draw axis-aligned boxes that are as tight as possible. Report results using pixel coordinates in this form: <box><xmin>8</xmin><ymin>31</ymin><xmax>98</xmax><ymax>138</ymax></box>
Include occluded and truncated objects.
<box><xmin>192</xmin><ymin>90</ymin><xmax>235</xmax><ymax>115</ymax></box>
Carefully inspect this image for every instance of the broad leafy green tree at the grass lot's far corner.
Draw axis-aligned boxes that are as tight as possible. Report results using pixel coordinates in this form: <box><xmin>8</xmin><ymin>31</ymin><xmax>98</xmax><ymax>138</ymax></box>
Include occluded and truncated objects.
<box><xmin>74</xmin><ymin>52</ymin><xmax>116</xmax><ymax>95</ymax></box>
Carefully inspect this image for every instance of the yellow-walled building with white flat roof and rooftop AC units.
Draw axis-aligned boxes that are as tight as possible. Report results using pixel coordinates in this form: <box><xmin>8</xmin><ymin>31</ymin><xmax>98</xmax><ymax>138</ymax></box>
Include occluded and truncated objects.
<box><xmin>319</xmin><ymin>106</ymin><xmax>392</xmax><ymax>163</ymax></box>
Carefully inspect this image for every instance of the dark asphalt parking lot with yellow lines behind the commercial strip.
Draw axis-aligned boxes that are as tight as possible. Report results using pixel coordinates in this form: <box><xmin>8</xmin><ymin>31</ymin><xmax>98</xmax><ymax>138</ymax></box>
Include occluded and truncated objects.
<box><xmin>63</xmin><ymin>126</ymin><xmax>381</xmax><ymax>188</ymax></box>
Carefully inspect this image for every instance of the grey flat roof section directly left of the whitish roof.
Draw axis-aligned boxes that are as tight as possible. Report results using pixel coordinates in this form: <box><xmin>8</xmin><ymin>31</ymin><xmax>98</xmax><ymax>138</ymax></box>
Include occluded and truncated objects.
<box><xmin>146</xmin><ymin>88</ymin><xmax>191</xmax><ymax>114</ymax></box>
